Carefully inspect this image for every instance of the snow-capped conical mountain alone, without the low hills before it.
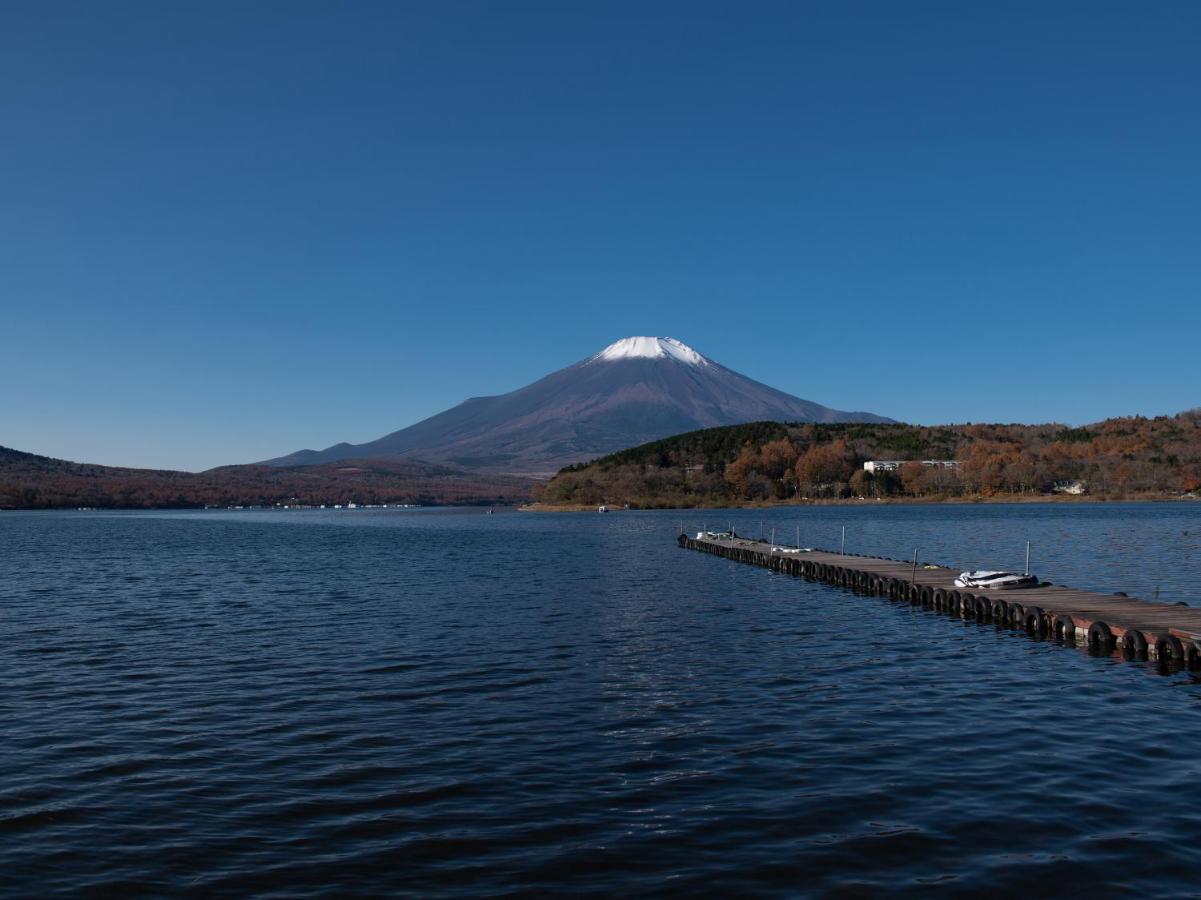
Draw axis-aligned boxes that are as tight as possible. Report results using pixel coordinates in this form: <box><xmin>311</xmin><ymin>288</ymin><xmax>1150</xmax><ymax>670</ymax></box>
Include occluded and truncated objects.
<box><xmin>263</xmin><ymin>338</ymin><xmax>892</xmax><ymax>476</ymax></box>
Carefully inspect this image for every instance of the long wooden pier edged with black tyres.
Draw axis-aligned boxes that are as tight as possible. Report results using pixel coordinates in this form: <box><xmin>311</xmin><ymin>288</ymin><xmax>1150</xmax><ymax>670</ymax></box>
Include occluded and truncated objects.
<box><xmin>679</xmin><ymin>535</ymin><xmax>1201</xmax><ymax>668</ymax></box>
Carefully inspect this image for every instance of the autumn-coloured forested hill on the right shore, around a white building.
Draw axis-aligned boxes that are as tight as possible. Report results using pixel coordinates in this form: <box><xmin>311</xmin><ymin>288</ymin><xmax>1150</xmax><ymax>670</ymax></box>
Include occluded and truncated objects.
<box><xmin>539</xmin><ymin>410</ymin><xmax>1201</xmax><ymax>507</ymax></box>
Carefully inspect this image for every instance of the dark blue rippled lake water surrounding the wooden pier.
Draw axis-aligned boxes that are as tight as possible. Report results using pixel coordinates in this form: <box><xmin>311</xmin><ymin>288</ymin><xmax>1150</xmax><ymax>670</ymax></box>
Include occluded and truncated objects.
<box><xmin>7</xmin><ymin>503</ymin><xmax>1201</xmax><ymax>896</ymax></box>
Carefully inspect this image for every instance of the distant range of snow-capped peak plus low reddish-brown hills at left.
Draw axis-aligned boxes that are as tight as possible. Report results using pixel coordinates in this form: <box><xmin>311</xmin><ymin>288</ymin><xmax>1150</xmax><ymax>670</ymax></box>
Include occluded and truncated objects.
<box><xmin>0</xmin><ymin>338</ymin><xmax>891</xmax><ymax>508</ymax></box>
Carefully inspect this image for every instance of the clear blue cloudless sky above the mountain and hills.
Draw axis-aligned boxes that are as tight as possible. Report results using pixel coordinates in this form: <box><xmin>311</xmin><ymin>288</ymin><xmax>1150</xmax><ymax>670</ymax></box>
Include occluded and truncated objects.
<box><xmin>0</xmin><ymin>0</ymin><xmax>1201</xmax><ymax>469</ymax></box>
